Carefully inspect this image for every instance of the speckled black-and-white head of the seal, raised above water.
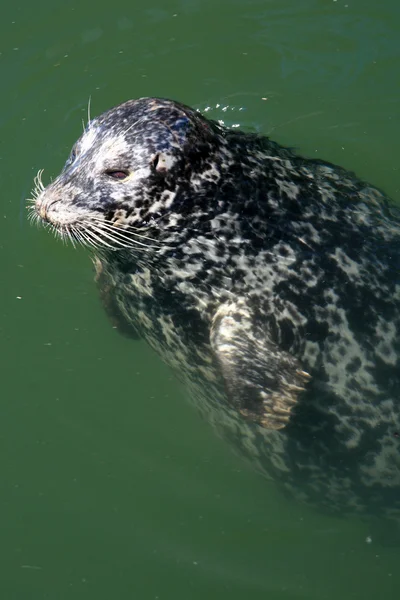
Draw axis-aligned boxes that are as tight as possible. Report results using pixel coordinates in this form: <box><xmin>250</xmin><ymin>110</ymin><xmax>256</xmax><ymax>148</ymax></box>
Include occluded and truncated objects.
<box><xmin>37</xmin><ymin>99</ymin><xmax>223</xmax><ymax>239</ymax></box>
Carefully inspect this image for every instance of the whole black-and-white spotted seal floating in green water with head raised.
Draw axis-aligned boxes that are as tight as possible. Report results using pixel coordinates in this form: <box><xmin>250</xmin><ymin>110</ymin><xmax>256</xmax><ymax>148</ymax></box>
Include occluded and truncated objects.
<box><xmin>33</xmin><ymin>98</ymin><xmax>400</xmax><ymax>516</ymax></box>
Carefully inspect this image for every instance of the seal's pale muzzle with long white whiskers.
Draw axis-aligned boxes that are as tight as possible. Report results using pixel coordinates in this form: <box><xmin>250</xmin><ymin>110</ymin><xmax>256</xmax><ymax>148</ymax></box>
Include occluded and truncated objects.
<box><xmin>27</xmin><ymin>170</ymin><xmax>164</xmax><ymax>252</ymax></box>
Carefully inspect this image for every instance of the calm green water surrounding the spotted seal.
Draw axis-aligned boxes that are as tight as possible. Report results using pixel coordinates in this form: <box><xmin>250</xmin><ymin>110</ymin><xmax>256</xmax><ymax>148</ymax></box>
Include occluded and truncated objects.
<box><xmin>0</xmin><ymin>0</ymin><xmax>400</xmax><ymax>600</ymax></box>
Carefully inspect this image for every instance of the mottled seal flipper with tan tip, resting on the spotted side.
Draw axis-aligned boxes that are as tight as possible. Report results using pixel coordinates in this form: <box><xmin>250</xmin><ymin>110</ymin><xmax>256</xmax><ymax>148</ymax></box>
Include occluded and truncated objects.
<box><xmin>210</xmin><ymin>303</ymin><xmax>311</xmax><ymax>429</ymax></box>
